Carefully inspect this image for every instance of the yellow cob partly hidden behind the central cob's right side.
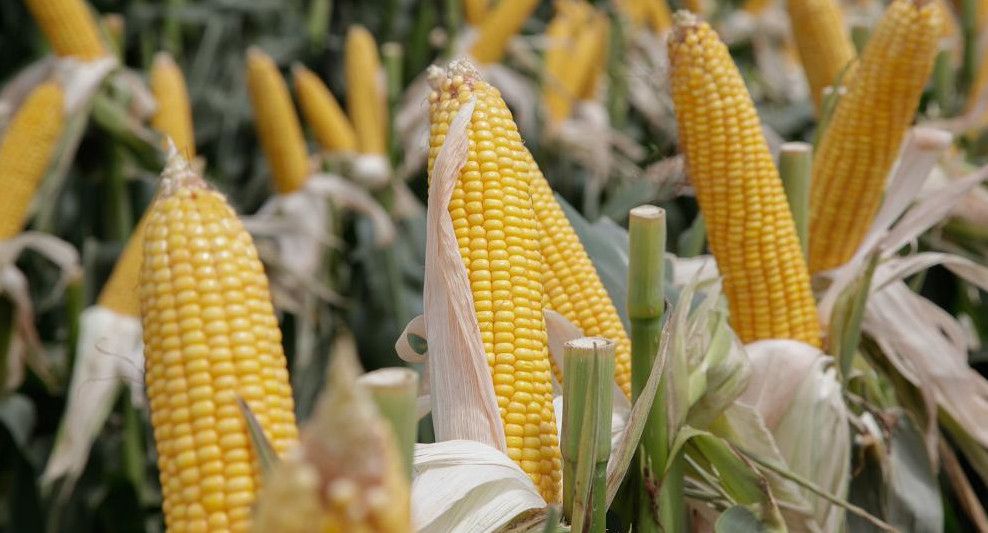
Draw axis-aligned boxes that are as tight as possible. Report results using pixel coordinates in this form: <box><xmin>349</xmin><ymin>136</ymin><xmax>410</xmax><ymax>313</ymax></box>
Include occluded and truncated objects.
<box><xmin>526</xmin><ymin>150</ymin><xmax>631</xmax><ymax>398</ymax></box>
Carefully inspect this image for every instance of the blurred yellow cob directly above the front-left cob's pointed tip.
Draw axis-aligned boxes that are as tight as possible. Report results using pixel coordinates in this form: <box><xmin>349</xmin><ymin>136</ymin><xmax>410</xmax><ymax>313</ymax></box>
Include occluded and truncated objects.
<box><xmin>151</xmin><ymin>52</ymin><xmax>196</xmax><ymax>159</ymax></box>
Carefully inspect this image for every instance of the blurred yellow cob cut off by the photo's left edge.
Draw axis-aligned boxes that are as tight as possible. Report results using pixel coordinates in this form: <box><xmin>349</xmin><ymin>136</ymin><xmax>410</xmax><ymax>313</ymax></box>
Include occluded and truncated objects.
<box><xmin>0</xmin><ymin>83</ymin><xmax>65</xmax><ymax>240</ymax></box>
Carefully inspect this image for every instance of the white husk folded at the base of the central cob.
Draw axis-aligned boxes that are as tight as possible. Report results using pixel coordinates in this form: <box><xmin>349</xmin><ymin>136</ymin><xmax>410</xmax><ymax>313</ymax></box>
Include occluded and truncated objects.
<box><xmin>412</xmin><ymin>440</ymin><xmax>546</xmax><ymax>533</ymax></box>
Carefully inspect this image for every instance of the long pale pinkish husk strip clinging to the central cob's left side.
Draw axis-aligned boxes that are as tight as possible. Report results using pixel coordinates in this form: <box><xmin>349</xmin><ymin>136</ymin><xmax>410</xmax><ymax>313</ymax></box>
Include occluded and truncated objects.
<box><xmin>424</xmin><ymin>95</ymin><xmax>506</xmax><ymax>452</ymax></box>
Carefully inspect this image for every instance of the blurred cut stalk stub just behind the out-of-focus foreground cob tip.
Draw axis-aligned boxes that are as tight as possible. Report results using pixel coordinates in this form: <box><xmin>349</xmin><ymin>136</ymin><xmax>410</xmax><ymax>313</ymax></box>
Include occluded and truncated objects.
<box><xmin>360</xmin><ymin>368</ymin><xmax>419</xmax><ymax>480</ymax></box>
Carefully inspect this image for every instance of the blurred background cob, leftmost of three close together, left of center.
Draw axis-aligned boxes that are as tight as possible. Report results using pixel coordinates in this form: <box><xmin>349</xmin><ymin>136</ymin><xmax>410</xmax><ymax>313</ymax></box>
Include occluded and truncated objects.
<box><xmin>247</xmin><ymin>47</ymin><xmax>309</xmax><ymax>194</ymax></box>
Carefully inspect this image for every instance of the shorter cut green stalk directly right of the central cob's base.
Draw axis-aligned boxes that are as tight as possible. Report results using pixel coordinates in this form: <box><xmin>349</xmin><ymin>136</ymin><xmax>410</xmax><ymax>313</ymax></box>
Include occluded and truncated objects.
<box><xmin>560</xmin><ymin>337</ymin><xmax>615</xmax><ymax>533</ymax></box>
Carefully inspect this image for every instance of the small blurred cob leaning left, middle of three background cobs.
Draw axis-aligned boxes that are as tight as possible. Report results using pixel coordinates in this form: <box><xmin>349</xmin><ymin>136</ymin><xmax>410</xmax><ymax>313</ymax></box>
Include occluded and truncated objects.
<box><xmin>292</xmin><ymin>63</ymin><xmax>357</xmax><ymax>152</ymax></box>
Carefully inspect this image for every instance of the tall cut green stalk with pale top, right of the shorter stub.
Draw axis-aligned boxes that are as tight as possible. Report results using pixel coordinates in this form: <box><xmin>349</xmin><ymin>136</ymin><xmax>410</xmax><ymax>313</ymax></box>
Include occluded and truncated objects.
<box><xmin>628</xmin><ymin>205</ymin><xmax>686</xmax><ymax>533</ymax></box>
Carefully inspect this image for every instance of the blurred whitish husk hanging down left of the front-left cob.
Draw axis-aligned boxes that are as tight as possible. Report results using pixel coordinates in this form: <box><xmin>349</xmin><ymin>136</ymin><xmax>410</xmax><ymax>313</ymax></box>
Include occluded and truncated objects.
<box><xmin>41</xmin><ymin>306</ymin><xmax>145</xmax><ymax>490</ymax></box>
